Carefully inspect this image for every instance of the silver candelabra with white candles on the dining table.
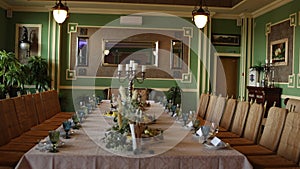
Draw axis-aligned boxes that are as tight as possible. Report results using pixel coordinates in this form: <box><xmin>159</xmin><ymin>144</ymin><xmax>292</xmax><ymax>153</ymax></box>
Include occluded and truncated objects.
<box><xmin>118</xmin><ymin>60</ymin><xmax>146</xmax><ymax>98</ymax></box>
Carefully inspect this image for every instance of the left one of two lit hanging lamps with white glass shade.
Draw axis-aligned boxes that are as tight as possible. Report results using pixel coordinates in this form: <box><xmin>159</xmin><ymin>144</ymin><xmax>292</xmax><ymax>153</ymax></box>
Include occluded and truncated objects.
<box><xmin>52</xmin><ymin>0</ymin><xmax>69</xmax><ymax>24</ymax></box>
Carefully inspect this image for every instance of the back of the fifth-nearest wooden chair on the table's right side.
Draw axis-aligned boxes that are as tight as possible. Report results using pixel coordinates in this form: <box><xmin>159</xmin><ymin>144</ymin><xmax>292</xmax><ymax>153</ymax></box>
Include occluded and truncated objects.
<box><xmin>219</xmin><ymin>98</ymin><xmax>237</xmax><ymax>131</ymax></box>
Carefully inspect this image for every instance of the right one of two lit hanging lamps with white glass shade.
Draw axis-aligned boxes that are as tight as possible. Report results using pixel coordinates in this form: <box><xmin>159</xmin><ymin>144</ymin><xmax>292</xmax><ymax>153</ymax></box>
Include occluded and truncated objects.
<box><xmin>192</xmin><ymin>0</ymin><xmax>209</xmax><ymax>29</ymax></box>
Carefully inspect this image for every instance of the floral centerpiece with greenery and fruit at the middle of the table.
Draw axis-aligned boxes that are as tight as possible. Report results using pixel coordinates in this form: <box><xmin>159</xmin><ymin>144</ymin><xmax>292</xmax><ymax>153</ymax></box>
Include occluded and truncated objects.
<box><xmin>103</xmin><ymin>86</ymin><xmax>163</xmax><ymax>153</ymax></box>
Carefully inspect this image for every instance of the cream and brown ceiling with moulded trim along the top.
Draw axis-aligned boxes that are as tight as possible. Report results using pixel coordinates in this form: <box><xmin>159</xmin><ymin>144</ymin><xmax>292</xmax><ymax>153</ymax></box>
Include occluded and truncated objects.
<box><xmin>0</xmin><ymin>0</ymin><xmax>293</xmax><ymax>18</ymax></box>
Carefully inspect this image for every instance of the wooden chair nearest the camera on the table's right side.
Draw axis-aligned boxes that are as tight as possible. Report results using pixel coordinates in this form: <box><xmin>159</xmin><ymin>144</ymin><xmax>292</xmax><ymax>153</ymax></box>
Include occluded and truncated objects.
<box><xmin>247</xmin><ymin>113</ymin><xmax>300</xmax><ymax>168</ymax></box>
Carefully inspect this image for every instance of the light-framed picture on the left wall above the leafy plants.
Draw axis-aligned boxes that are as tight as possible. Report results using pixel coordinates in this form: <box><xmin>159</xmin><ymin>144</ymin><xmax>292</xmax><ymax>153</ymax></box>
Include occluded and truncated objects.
<box><xmin>15</xmin><ymin>24</ymin><xmax>42</xmax><ymax>63</ymax></box>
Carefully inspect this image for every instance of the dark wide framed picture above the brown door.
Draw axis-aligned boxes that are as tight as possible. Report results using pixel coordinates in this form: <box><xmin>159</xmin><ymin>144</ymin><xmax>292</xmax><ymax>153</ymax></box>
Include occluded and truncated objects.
<box><xmin>211</xmin><ymin>34</ymin><xmax>240</xmax><ymax>46</ymax></box>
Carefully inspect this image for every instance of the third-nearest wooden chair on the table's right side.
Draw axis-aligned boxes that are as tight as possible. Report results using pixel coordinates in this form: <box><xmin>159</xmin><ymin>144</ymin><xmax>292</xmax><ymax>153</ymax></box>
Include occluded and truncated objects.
<box><xmin>223</xmin><ymin>103</ymin><xmax>264</xmax><ymax>146</ymax></box>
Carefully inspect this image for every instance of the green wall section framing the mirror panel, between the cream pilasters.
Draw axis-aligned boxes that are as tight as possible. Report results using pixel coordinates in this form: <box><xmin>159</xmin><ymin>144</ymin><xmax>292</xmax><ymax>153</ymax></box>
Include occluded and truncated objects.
<box><xmin>60</xmin><ymin>13</ymin><xmax>198</xmax><ymax>111</ymax></box>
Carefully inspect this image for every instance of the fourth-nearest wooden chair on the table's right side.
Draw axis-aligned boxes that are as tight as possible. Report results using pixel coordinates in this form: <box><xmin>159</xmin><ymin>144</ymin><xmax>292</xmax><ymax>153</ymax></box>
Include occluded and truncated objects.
<box><xmin>217</xmin><ymin>101</ymin><xmax>250</xmax><ymax>139</ymax></box>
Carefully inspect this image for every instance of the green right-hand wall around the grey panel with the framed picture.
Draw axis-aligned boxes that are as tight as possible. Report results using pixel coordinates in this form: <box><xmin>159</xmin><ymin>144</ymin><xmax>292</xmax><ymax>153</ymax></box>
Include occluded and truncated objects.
<box><xmin>253</xmin><ymin>0</ymin><xmax>300</xmax><ymax>101</ymax></box>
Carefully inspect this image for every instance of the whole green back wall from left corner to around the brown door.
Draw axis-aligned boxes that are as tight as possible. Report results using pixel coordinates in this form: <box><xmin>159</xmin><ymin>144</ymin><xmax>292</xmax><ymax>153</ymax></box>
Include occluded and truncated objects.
<box><xmin>0</xmin><ymin>10</ymin><xmax>244</xmax><ymax>111</ymax></box>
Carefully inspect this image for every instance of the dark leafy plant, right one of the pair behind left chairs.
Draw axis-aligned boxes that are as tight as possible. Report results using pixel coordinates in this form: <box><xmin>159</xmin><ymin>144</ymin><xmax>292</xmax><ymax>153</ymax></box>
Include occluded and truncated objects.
<box><xmin>27</xmin><ymin>56</ymin><xmax>51</xmax><ymax>91</ymax></box>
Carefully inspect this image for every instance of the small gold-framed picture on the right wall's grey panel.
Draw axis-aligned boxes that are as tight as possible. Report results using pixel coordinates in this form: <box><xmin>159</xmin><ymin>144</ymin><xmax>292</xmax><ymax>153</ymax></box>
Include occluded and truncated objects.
<box><xmin>270</xmin><ymin>38</ymin><xmax>288</xmax><ymax>66</ymax></box>
